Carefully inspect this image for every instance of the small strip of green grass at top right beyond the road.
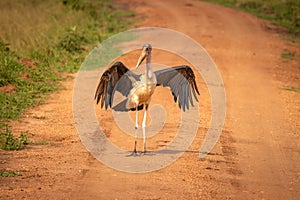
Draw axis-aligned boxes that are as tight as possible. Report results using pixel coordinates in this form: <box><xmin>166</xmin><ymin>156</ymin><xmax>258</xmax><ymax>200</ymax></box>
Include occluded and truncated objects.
<box><xmin>206</xmin><ymin>0</ymin><xmax>300</xmax><ymax>41</ymax></box>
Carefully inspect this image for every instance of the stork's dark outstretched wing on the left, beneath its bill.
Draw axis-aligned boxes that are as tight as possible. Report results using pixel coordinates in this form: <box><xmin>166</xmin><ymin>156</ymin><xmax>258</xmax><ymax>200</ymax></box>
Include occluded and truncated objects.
<box><xmin>95</xmin><ymin>62</ymin><xmax>136</xmax><ymax>109</ymax></box>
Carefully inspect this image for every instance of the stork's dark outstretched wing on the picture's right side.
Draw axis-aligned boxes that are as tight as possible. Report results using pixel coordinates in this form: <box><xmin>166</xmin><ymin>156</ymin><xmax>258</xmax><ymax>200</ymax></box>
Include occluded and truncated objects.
<box><xmin>154</xmin><ymin>65</ymin><xmax>200</xmax><ymax>111</ymax></box>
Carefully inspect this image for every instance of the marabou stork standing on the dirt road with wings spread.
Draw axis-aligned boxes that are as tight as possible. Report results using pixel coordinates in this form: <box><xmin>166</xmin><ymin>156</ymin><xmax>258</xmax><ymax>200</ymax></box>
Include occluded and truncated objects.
<box><xmin>95</xmin><ymin>44</ymin><xmax>200</xmax><ymax>156</ymax></box>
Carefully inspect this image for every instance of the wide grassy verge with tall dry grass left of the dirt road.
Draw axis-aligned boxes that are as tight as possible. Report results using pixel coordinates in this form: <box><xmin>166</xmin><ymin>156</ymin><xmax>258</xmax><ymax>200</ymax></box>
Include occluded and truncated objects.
<box><xmin>0</xmin><ymin>0</ymin><xmax>134</xmax><ymax>150</ymax></box>
